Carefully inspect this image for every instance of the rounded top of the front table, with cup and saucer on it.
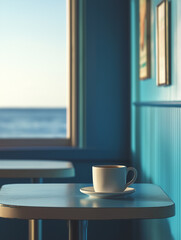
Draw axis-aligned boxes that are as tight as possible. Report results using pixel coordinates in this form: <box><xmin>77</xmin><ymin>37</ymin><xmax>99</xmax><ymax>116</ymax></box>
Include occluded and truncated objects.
<box><xmin>0</xmin><ymin>184</ymin><xmax>175</xmax><ymax>220</ymax></box>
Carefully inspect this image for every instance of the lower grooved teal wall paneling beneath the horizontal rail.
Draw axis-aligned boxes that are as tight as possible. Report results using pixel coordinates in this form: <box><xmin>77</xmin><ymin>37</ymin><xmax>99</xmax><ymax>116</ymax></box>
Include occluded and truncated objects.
<box><xmin>133</xmin><ymin>107</ymin><xmax>181</xmax><ymax>240</ymax></box>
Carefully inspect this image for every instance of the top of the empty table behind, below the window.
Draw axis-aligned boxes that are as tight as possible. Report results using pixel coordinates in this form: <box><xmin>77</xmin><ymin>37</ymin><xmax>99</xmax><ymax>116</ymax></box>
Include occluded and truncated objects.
<box><xmin>0</xmin><ymin>160</ymin><xmax>75</xmax><ymax>178</ymax></box>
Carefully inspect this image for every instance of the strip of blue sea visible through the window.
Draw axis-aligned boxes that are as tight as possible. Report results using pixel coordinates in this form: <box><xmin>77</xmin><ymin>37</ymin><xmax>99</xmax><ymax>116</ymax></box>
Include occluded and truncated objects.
<box><xmin>0</xmin><ymin>108</ymin><xmax>67</xmax><ymax>139</ymax></box>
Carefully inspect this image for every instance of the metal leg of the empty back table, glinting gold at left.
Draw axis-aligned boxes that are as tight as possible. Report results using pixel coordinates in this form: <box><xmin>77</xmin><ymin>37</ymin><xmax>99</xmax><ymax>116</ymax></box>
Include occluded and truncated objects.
<box><xmin>28</xmin><ymin>178</ymin><xmax>43</xmax><ymax>240</ymax></box>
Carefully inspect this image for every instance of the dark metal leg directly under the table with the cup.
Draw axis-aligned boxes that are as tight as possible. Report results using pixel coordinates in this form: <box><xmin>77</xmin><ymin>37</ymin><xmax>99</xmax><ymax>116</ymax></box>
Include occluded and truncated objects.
<box><xmin>68</xmin><ymin>220</ymin><xmax>88</xmax><ymax>240</ymax></box>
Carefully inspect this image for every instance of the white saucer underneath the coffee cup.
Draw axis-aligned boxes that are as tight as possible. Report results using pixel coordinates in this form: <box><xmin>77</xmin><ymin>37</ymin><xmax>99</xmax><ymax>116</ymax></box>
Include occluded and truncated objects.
<box><xmin>80</xmin><ymin>186</ymin><xmax>135</xmax><ymax>198</ymax></box>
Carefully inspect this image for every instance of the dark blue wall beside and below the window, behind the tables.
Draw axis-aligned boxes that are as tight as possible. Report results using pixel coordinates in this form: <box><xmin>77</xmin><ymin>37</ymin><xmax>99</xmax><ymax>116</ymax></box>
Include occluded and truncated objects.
<box><xmin>0</xmin><ymin>0</ymin><xmax>130</xmax><ymax>240</ymax></box>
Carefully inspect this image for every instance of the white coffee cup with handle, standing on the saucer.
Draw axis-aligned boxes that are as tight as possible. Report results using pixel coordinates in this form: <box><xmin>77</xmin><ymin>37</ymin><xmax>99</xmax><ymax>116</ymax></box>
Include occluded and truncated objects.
<box><xmin>92</xmin><ymin>165</ymin><xmax>137</xmax><ymax>193</ymax></box>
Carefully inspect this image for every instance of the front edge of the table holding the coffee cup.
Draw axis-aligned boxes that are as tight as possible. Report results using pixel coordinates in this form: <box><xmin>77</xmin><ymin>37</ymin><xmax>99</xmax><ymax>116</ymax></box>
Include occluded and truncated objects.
<box><xmin>0</xmin><ymin>203</ymin><xmax>175</xmax><ymax>220</ymax></box>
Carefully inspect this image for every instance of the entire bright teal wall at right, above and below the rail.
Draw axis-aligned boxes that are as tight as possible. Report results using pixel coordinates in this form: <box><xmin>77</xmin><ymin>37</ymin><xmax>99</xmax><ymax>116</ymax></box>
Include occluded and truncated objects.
<box><xmin>131</xmin><ymin>0</ymin><xmax>181</xmax><ymax>240</ymax></box>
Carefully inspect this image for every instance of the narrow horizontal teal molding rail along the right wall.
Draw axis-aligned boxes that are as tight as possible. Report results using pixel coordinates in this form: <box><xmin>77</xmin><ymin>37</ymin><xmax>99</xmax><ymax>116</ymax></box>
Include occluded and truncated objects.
<box><xmin>133</xmin><ymin>101</ymin><xmax>181</xmax><ymax>108</ymax></box>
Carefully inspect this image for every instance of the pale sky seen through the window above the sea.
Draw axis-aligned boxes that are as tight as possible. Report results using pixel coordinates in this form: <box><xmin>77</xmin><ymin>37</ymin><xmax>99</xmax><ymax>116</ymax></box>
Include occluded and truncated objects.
<box><xmin>0</xmin><ymin>0</ymin><xmax>67</xmax><ymax>108</ymax></box>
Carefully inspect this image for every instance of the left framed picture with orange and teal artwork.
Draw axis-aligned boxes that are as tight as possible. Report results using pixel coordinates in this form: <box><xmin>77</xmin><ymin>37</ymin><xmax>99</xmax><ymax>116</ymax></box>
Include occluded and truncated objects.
<box><xmin>139</xmin><ymin>0</ymin><xmax>151</xmax><ymax>80</ymax></box>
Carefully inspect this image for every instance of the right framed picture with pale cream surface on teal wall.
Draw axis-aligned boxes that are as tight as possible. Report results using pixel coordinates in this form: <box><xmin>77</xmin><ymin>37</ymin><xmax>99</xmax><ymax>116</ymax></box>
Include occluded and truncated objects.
<box><xmin>157</xmin><ymin>0</ymin><xmax>170</xmax><ymax>86</ymax></box>
